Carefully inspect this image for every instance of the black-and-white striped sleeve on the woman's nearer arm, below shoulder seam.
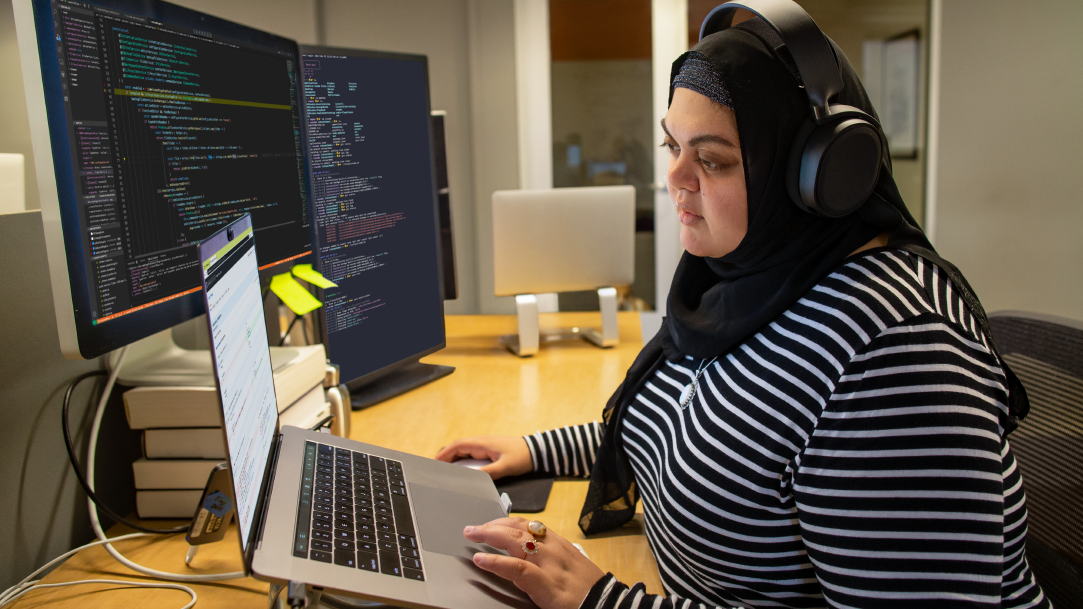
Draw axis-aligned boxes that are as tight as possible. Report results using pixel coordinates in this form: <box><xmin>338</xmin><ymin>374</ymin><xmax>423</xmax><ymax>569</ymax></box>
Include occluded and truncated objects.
<box><xmin>793</xmin><ymin>314</ymin><xmax>1043</xmax><ymax>609</ymax></box>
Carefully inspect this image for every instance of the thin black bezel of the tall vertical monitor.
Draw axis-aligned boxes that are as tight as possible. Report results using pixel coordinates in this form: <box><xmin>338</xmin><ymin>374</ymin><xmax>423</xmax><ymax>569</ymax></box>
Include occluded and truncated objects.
<box><xmin>298</xmin><ymin>44</ymin><xmax>447</xmax><ymax>390</ymax></box>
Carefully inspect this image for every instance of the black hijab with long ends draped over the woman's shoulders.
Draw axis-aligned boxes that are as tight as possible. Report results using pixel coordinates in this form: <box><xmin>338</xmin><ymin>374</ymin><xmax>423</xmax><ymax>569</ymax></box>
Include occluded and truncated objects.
<box><xmin>579</xmin><ymin>17</ymin><xmax>1030</xmax><ymax>535</ymax></box>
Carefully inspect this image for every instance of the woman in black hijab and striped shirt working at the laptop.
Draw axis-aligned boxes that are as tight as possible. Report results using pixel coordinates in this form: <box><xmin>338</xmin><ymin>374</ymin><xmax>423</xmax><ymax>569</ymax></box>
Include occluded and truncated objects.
<box><xmin>438</xmin><ymin>14</ymin><xmax>1048</xmax><ymax>608</ymax></box>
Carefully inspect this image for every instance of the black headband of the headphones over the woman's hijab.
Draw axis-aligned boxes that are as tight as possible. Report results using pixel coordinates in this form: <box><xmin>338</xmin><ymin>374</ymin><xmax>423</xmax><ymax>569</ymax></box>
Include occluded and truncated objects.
<box><xmin>700</xmin><ymin>0</ymin><xmax>843</xmax><ymax>124</ymax></box>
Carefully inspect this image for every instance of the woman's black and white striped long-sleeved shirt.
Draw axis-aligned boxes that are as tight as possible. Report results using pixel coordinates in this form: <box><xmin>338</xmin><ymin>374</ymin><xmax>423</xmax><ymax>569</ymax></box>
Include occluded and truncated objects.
<box><xmin>526</xmin><ymin>249</ymin><xmax>1049</xmax><ymax>608</ymax></box>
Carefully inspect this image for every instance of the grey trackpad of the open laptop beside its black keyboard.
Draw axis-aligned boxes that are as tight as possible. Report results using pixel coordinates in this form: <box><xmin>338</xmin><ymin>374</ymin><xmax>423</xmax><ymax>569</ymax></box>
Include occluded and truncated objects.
<box><xmin>409</xmin><ymin>482</ymin><xmax>504</xmax><ymax>558</ymax></box>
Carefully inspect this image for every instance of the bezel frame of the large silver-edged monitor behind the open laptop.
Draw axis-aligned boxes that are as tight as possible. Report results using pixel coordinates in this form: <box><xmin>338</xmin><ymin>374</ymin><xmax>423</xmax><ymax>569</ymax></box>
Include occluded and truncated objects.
<box><xmin>14</xmin><ymin>0</ymin><xmax>315</xmax><ymax>360</ymax></box>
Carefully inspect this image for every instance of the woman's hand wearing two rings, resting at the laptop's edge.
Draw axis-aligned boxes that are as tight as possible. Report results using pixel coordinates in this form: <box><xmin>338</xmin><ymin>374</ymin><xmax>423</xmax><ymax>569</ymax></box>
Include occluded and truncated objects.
<box><xmin>462</xmin><ymin>518</ymin><xmax>605</xmax><ymax>609</ymax></box>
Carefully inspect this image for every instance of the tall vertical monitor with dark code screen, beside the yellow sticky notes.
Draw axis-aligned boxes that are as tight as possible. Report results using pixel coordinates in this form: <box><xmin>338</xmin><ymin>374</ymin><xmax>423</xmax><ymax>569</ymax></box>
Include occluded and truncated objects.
<box><xmin>301</xmin><ymin>46</ymin><xmax>453</xmax><ymax>407</ymax></box>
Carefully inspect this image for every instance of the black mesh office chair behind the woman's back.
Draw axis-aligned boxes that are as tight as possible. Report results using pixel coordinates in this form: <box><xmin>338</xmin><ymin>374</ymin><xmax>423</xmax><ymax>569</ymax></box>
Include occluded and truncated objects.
<box><xmin>989</xmin><ymin>311</ymin><xmax>1083</xmax><ymax>609</ymax></box>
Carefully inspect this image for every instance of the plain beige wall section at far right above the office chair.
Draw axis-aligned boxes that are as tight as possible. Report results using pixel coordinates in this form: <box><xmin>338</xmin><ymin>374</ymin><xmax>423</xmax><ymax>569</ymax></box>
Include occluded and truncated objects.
<box><xmin>936</xmin><ymin>0</ymin><xmax>1083</xmax><ymax>320</ymax></box>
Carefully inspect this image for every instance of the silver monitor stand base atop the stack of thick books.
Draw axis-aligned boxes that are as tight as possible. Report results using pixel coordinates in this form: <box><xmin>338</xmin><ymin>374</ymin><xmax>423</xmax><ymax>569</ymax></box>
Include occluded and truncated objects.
<box><xmin>106</xmin><ymin>329</ymin><xmax>299</xmax><ymax>387</ymax></box>
